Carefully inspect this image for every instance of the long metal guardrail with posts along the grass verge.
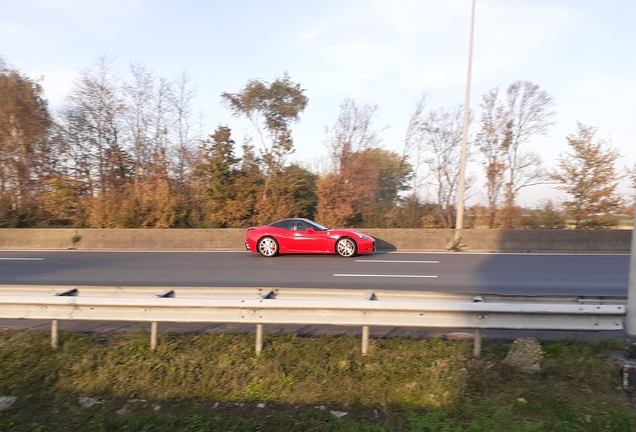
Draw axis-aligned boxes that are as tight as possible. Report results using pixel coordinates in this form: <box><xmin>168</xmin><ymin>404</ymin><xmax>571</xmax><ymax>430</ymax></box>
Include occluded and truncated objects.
<box><xmin>0</xmin><ymin>285</ymin><xmax>626</xmax><ymax>357</ymax></box>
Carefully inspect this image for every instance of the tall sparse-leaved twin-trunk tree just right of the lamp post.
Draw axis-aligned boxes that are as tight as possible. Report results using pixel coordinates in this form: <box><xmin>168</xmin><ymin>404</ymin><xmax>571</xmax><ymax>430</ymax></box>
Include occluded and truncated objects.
<box><xmin>477</xmin><ymin>81</ymin><xmax>554</xmax><ymax>228</ymax></box>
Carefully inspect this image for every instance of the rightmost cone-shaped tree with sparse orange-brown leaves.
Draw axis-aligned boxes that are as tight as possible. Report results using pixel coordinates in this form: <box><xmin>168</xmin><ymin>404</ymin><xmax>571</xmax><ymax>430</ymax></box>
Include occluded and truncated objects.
<box><xmin>550</xmin><ymin>123</ymin><xmax>621</xmax><ymax>228</ymax></box>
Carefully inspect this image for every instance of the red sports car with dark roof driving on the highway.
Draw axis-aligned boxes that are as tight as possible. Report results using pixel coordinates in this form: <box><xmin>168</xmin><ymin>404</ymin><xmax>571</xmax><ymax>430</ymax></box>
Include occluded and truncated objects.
<box><xmin>245</xmin><ymin>218</ymin><xmax>375</xmax><ymax>257</ymax></box>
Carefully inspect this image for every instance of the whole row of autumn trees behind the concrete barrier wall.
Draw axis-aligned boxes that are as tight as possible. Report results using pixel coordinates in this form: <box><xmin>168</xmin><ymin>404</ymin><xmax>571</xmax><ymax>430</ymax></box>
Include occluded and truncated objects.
<box><xmin>0</xmin><ymin>52</ymin><xmax>636</xmax><ymax>228</ymax></box>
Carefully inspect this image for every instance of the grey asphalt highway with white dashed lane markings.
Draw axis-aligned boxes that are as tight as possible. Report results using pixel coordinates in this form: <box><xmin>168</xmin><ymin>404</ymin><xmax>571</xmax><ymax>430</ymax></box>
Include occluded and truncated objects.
<box><xmin>0</xmin><ymin>251</ymin><xmax>630</xmax><ymax>296</ymax></box>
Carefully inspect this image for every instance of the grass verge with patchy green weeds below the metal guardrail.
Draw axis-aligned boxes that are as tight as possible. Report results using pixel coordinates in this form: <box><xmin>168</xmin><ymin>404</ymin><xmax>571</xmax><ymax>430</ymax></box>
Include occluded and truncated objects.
<box><xmin>0</xmin><ymin>331</ymin><xmax>636</xmax><ymax>432</ymax></box>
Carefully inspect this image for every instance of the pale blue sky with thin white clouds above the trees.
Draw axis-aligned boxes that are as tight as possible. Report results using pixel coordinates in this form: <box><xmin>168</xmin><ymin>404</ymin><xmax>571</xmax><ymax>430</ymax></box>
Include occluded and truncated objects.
<box><xmin>0</xmin><ymin>0</ymin><xmax>636</xmax><ymax>206</ymax></box>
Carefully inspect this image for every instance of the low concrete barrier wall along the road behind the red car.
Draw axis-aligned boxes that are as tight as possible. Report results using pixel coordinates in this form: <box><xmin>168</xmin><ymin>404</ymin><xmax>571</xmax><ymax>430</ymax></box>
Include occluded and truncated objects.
<box><xmin>0</xmin><ymin>228</ymin><xmax>632</xmax><ymax>253</ymax></box>
